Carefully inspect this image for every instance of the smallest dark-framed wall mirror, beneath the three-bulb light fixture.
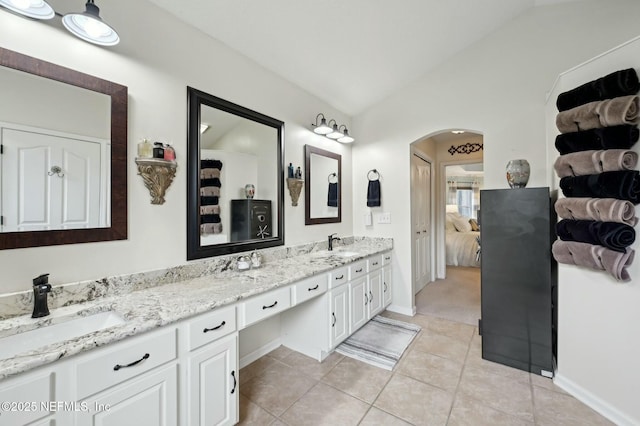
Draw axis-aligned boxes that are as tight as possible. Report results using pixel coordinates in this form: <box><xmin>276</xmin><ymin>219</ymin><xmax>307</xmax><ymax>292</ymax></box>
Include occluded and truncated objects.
<box><xmin>304</xmin><ymin>145</ymin><xmax>342</xmax><ymax>225</ymax></box>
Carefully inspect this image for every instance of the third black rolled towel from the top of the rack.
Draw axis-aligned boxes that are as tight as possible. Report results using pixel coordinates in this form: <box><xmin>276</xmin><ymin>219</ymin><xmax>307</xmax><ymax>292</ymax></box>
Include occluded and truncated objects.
<box><xmin>560</xmin><ymin>170</ymin><xmax>640</xmax><ymax>204</ymax></box>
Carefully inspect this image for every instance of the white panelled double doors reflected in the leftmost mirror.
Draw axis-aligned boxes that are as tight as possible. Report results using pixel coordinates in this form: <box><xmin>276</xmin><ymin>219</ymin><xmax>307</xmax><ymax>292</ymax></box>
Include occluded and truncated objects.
<box><xmin>0</xmin><ymin>128</ymin><xmax>105</xmax><ymax>232</ymax></box>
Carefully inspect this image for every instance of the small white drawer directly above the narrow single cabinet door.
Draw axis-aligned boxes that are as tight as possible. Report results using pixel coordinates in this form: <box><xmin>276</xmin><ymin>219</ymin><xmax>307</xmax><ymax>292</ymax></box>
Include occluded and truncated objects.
<box><xmin>189</xmin><ymin>306</ymin><xmax>236</xmax><ymax>351</ymax></box>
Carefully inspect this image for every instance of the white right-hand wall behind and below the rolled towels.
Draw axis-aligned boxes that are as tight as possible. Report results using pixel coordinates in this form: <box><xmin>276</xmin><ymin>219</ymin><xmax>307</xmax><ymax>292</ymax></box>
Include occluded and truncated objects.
<box><xmin>546</xmin><ymin>39</ymin><xmax>640</xmax><ymax>425</ymax></box>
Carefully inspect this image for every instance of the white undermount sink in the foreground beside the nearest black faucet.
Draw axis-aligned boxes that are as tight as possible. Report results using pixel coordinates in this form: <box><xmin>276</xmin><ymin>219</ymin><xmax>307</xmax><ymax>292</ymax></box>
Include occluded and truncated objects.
<box><xmin>0</xmin><ymin>311</ymin><xmax>125</xmax><ymax>359</ymax></box>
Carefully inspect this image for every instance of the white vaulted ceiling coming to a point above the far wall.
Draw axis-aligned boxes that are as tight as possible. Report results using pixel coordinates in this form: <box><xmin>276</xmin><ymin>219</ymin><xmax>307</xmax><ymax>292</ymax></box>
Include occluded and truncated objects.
<box><xmin>150</xmin><ymin>0</ymin><xmax>588</xmax><ymax>115</ymax></box>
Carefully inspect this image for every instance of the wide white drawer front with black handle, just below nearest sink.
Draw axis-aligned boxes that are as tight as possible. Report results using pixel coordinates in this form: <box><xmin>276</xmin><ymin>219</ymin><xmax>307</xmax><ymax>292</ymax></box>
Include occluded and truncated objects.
<box><xmin>76</xmin><ymin>327</ymin><xmax>177</xmax><ymax>399</ymax></box>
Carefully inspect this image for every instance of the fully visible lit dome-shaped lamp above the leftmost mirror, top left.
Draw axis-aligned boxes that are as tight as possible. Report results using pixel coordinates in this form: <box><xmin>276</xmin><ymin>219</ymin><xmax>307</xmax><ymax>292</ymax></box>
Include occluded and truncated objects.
<box><xmin>62</xmin><ymin>0</ymin><xmax>120</xmax><ymax>46</ymax></box>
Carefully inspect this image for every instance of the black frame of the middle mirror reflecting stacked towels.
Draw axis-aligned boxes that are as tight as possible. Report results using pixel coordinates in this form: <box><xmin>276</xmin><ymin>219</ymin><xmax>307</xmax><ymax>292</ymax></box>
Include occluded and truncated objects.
<box><xmin>187</xmin><ymin>87</ymin><xmax>284</xmax><ymax>260</ymax></box>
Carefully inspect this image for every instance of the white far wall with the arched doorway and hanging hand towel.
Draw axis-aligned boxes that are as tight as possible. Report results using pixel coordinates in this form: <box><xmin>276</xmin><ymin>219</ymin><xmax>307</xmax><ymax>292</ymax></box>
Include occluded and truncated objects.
<box><xmin>353</xmin><ymin>0</ymin><xmax>640</xmax><ymax>318</ymax></box>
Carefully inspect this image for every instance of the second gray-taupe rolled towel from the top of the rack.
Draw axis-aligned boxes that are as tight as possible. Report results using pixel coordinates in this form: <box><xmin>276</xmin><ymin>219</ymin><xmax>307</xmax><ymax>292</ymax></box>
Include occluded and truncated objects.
<box><xmin>553</xmin><ymin>149</ymin><xmax>638</xmax><ymax>178</ymax></box>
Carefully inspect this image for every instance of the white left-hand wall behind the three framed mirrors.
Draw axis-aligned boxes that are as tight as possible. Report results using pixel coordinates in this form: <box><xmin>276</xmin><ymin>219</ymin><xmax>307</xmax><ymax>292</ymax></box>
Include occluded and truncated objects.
<box><xmin>0</xmin><ymin>0</ymin><xmax>353</xmax><ymax>293</ymax></box>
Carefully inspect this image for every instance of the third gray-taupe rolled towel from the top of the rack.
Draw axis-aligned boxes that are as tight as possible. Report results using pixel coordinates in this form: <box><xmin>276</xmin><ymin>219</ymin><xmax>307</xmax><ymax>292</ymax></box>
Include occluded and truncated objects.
<box><xmin>554</xmin><ymin>197</ymin><xmax>638</xmax><ymax>226</ymax></box>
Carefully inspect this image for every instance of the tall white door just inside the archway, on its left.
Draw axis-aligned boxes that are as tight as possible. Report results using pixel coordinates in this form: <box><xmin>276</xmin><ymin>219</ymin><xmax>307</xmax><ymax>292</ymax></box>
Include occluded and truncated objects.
<box><xmin>411</xmin><ymin>154</ymin><xmax>431</xmax><ymax>293</ymax></box>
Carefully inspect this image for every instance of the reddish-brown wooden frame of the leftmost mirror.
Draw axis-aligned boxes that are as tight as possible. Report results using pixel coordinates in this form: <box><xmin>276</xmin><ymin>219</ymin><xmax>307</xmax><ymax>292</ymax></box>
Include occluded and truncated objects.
<box><xmin>0</xmin><ymin>47</ymin><xmax>128</xmax><ymax>249</ymax></box>
